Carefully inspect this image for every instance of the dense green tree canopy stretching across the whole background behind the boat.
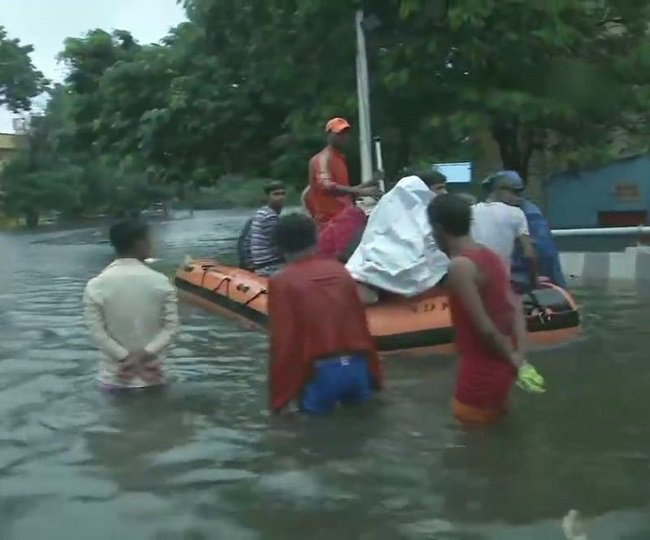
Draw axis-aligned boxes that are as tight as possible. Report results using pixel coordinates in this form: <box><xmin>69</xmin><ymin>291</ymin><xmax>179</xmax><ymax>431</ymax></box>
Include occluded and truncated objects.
<box><xmin>0</xmin><ymin>0</ymin><xmax>650</xmax><ymax>224</ymax></box>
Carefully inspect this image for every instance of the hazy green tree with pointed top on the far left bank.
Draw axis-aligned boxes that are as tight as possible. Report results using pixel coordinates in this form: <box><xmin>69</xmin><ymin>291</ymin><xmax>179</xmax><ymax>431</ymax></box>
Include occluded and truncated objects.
<box><xmin>3</xmin><ymin>79</ymin><xmax>171</xmax><ymax>226</ymax></box>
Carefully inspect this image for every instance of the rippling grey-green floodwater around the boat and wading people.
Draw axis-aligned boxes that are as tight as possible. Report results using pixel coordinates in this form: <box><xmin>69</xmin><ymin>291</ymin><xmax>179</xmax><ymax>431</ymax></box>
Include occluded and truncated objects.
<box><xmin>0</xmin><ymin>212</ymin><xmax>650</xmax><ymax>540</ymax></box>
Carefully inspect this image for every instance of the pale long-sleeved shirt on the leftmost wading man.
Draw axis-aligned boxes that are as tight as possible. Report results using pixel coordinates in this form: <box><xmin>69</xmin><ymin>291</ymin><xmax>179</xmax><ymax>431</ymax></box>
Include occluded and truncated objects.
<box><xmin>83</xmin><ymin>259</ymin><xmax>178</xmax><ymax>388</ymax></box>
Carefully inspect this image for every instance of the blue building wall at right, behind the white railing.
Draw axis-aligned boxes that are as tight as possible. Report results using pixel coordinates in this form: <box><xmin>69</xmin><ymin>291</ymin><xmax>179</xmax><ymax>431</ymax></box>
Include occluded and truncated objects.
<box><xmin>545</xmin><ymin>155</ymin><xmax>650</xmax><ymax>228</ymax></box>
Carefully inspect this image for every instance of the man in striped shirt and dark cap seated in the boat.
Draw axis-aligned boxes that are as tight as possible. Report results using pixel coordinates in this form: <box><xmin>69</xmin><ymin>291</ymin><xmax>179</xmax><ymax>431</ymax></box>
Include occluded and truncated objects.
<box><xmin>238</xmin><ymin>182</ymin><xmax>285</xmax><ymax>276</ymax></box>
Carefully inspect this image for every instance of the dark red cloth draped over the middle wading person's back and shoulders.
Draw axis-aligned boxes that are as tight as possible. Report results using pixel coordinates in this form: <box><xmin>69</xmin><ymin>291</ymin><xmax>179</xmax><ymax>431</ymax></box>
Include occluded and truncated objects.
<box><xmin>268</xmin><ymin>256</ymin><xmax>383</xmax><ymax>411</ymax></box>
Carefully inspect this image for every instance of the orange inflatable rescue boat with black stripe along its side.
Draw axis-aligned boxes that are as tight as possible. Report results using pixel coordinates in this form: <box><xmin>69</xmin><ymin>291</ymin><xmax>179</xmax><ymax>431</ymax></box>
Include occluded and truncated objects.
<box><xmin>175</xmin><ymin>259</ymin><xmax>580</xmax><ymax>353</ymax></box>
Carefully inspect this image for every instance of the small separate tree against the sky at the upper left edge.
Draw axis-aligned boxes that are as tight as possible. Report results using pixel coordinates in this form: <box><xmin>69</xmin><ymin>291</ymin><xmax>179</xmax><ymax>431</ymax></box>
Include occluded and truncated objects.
<box><xmin>0</xmin><ymin>26</ymin><xmax>46</xmax><ymax>112</ymax></box>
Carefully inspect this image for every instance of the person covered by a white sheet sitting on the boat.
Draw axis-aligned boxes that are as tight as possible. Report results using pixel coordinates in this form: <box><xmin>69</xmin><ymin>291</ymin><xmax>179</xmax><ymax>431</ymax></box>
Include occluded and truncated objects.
<box><xmin>346</xmin><ymin>171</ymin><xmax>449</xmax><ymax>303</ymax></box>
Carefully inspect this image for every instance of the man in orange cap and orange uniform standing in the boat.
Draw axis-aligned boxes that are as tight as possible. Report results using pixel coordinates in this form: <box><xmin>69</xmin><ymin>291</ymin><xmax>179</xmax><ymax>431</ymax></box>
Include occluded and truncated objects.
<box><xmin>305</xmin><ymin>118</ymin><xmax>379</xmax><ymax>229</ymax></box>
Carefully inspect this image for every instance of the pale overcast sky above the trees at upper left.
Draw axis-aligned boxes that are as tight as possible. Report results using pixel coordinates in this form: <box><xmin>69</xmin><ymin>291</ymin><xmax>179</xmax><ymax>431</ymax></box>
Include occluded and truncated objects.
<box><xmin>0</xmin><ymin>0</ymin><xmax>185</xmax><ymax>133</ymax></box>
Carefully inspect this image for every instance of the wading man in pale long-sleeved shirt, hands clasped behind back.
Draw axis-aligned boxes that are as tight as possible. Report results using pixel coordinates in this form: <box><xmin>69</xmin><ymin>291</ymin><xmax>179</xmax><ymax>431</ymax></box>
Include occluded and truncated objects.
<box><xmin>83</xmin><ymin>219</ymin><xmax>178</xmax><ymax>389</ymax></box>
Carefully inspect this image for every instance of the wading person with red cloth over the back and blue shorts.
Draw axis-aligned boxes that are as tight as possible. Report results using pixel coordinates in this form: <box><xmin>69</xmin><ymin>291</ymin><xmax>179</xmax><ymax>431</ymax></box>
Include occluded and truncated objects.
<box><xmin>268</xmin><ymin>214</ymin><xmax>383</xmax><ymax>414</ymax></box>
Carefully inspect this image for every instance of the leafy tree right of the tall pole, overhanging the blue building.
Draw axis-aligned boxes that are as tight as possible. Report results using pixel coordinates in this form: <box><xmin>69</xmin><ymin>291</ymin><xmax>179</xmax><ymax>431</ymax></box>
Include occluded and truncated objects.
<box><xmin>383</xmin><ymin>0</ymin><xmax>649</xmax><ymax>178</ymax></box>
